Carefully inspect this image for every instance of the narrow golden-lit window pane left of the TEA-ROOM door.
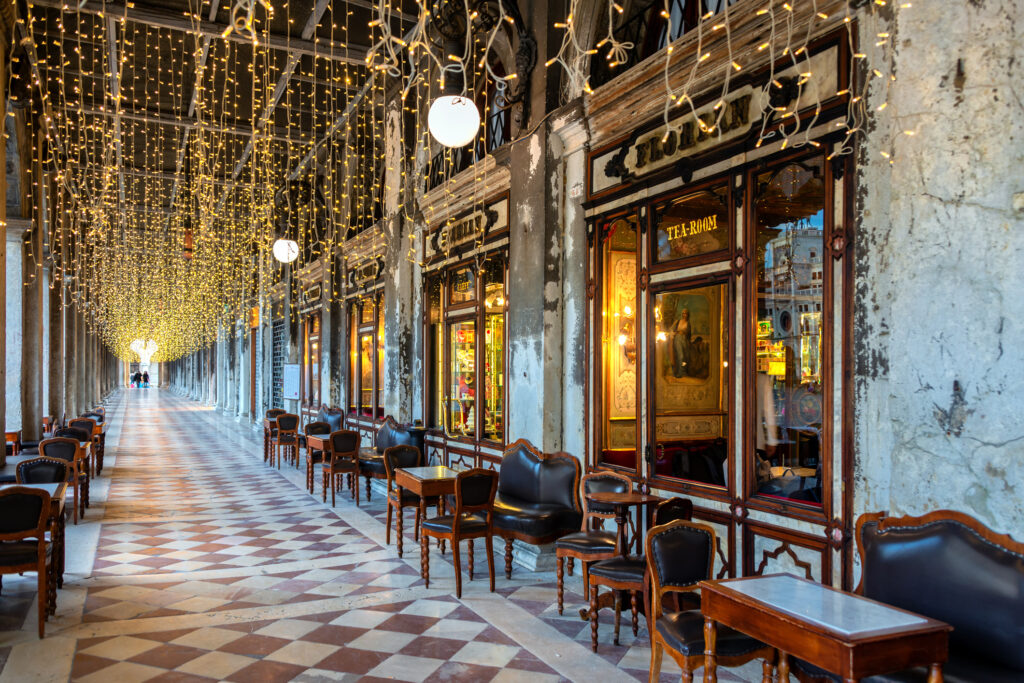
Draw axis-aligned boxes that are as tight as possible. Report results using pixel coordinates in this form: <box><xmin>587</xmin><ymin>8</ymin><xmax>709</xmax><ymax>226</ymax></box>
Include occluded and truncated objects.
<box><xmin>598</xmin><ymin>216</ymin><xmax>639</xmax><ymax>470</ymax></box>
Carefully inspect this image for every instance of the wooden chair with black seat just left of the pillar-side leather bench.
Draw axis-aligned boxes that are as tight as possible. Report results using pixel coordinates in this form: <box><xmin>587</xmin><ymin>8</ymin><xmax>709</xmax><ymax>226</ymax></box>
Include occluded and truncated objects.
<box><xmin>420</xmin><ymin>467</ymin><xmax>498</xmax><ymax>598</ymax></box>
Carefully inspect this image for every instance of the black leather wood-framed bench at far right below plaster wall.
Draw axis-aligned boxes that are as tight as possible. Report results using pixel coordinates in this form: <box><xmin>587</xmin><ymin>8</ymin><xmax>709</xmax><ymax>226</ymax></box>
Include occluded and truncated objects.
<box><xmin>793</xmin><ymin>510</ymin><xmax>1024</xmax><ymax>683</ymax></box>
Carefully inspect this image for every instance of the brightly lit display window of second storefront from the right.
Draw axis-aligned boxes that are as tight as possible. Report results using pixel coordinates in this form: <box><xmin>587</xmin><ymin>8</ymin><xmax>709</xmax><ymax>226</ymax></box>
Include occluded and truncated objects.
<box><xmin>426</xmin><ymin>255</ymin><xmax>508</xmax><ymax>442</ymax></box>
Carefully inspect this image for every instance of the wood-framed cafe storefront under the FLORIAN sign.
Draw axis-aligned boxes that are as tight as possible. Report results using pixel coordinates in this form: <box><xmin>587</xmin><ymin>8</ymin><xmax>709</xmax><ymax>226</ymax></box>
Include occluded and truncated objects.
<box><xmin>585</xmin><ymin>34</ymin><xmax>853</xmax><ymax>587</ymax></box>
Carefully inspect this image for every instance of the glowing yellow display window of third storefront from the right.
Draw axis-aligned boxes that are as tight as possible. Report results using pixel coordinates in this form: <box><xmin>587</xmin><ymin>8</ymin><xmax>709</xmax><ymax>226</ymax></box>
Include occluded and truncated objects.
<box><xmin>348</xmin><ymin>297</ymin><xmax>384</xmax><ymax>419</ymax></box>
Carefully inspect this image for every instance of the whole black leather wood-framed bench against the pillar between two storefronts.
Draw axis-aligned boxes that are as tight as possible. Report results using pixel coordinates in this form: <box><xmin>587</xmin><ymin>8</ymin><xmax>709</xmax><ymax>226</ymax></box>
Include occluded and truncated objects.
<box><xmin>494</xmin><ymin>439</ymin><xmax>583</xmax><ymax>578</ymax></box>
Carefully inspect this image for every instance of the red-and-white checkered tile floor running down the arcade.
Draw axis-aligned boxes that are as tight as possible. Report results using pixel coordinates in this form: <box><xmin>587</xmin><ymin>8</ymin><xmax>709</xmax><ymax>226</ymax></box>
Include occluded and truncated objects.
<box><xmin>0</xmin><ymin>389</ymin><xmax>761</xmax><ymax>683</ymax></box>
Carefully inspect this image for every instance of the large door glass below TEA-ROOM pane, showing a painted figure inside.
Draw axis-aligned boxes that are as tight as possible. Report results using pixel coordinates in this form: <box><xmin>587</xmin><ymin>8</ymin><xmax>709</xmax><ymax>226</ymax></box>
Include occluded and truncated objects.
<box><xmin>649</xmin><ymin>283</ymin><xmax>730</xmax><ymax>488</ymax></box>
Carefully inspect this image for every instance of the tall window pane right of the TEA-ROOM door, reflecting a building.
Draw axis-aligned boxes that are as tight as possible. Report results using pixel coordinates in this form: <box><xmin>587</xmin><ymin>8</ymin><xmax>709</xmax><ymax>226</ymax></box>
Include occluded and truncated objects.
<box><xmin>754</xmin><ymin>159</ymin><xmax>829</xmax><ymax>505</ymax></box>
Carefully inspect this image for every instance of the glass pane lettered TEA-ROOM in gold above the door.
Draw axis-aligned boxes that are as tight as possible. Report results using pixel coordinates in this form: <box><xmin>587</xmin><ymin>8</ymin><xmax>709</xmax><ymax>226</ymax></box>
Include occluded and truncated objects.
<box><xmin>651</xmin><ymin>183</ymin><xmax>732</xmax><ymax>263</ymax></box>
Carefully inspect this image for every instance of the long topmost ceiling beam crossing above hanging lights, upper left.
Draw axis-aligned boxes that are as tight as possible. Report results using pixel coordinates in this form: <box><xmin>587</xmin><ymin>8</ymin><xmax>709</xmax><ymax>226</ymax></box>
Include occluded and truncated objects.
<box><xmin>24</xmin><ymin>0</ymin><xmax>368</xmax><ymax>67</ymax></box>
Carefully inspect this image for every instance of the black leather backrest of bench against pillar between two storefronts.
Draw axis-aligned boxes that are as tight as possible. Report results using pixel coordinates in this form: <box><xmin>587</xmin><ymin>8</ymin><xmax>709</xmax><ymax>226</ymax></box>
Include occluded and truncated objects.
<box><xmin>498</xmin><ymin>440</ymin><xmax>580</xmax><ymax>510</ymax></box>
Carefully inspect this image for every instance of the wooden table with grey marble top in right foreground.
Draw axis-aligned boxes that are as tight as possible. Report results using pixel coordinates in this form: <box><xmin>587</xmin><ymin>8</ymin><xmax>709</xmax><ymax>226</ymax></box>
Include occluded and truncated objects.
<box><xmin>700</xmin><ymin>574</ymin><xmax>952</xmax><ymax>683</ymax></box>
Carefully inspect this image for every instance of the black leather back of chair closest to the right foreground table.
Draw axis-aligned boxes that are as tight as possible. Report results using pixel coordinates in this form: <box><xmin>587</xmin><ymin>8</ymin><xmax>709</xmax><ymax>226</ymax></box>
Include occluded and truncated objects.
<box><xmin>647</xmin><ymin>521</ymin><xmax>715</xmax><ymax>588</ymax></box>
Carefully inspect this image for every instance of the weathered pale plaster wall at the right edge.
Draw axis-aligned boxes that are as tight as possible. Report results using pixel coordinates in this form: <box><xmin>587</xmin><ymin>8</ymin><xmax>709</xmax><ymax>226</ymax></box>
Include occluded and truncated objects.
<box><xmin>854</xmin><ymin>0</ymin><xmax>1024</xmax><ymax>538</ymax></box>
